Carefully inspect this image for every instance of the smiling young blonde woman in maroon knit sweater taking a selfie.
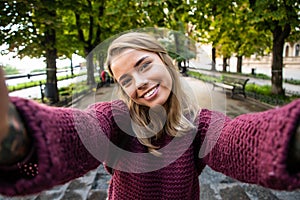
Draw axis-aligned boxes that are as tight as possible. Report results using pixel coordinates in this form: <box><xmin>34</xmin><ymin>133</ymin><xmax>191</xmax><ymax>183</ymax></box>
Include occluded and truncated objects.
<box><xmin>0</xmin><ymin>32</ymin><xmax>300</xmax><ymax>200</ymax></box>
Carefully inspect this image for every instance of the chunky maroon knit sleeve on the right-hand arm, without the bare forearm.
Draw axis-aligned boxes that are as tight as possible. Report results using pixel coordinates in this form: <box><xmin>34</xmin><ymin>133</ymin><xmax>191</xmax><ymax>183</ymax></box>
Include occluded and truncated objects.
<box><xmin>199</xmin><ymin>99</ymin><xmax>300</xmax><ymax>190</ymax></box>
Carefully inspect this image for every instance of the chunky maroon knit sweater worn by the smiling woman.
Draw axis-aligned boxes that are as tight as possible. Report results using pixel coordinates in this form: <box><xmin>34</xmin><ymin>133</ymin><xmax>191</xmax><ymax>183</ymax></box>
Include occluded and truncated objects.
<box><xmin>0</xmin><ymin>98</ymin><xmax>300</xmax><ymax>200</ymax></box>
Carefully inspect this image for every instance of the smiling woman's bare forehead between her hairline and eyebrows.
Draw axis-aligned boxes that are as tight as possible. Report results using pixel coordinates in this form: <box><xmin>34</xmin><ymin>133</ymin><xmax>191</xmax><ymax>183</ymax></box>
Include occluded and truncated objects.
<box><xmin>111</xmin><ymin>49</ymin><xmax>157</xmax><ymax>80</ymax></box>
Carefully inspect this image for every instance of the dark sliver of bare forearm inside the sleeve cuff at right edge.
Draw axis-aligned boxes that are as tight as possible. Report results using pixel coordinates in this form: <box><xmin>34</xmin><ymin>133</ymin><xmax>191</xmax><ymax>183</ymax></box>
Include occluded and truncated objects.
<box><xmin>287</xmin><ymin>122</ymin><xmax>300</xmax><ymax>173</ymax></box>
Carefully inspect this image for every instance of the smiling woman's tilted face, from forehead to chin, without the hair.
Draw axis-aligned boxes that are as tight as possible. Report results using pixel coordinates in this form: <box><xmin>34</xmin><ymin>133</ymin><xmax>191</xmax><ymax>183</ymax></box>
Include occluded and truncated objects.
<box><xmin>111</xmin><ymin>49</ymin><xmax>172</xmax><ymax>107</ymax></box>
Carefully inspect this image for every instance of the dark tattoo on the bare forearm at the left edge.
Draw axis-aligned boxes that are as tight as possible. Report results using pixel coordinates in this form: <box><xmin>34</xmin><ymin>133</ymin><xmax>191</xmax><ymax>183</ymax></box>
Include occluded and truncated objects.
<box><xmin>0</xmin><ymin>103</ymin><xmax>30</xmax><ymax>165</ymax></box>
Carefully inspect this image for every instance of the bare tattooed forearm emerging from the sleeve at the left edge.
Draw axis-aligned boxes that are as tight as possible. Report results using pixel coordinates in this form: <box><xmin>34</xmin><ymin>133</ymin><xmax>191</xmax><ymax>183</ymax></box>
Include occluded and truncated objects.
<box><xmin>0</xmin><ymin>69</ymin><xmax>30</xmax><ymax>166</ymax></box>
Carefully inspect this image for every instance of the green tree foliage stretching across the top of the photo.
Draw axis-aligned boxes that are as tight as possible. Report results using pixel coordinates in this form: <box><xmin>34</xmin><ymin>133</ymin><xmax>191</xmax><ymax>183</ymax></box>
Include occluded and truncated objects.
<box><xmin>0</xmin><ymin>0</ymin><xmax>300</xmax><ymax>69</ymax></box>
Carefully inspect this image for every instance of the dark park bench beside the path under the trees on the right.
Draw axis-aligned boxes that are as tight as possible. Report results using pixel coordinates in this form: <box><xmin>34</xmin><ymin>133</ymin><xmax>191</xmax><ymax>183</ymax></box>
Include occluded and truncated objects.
<box><xmin>213</xmin><ymin>76</ymin><xmax>249</xmax><ymax>98</ymax></box>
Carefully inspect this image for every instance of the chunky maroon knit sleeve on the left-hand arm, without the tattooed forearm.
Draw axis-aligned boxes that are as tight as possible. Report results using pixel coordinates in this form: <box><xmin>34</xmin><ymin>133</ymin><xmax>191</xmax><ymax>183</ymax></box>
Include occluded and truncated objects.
<box><xmin>0</xmin><ymin>98</ymin><xmax>126</xmax><ymax>196</ymax></box>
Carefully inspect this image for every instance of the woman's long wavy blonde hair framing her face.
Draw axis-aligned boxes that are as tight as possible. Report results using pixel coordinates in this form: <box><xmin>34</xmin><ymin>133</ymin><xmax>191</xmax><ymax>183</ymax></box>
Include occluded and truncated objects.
<box><xmin>106</xmin><ymin>32</ymin><xmax>198</xmax><ymax>155</ymax></box>
